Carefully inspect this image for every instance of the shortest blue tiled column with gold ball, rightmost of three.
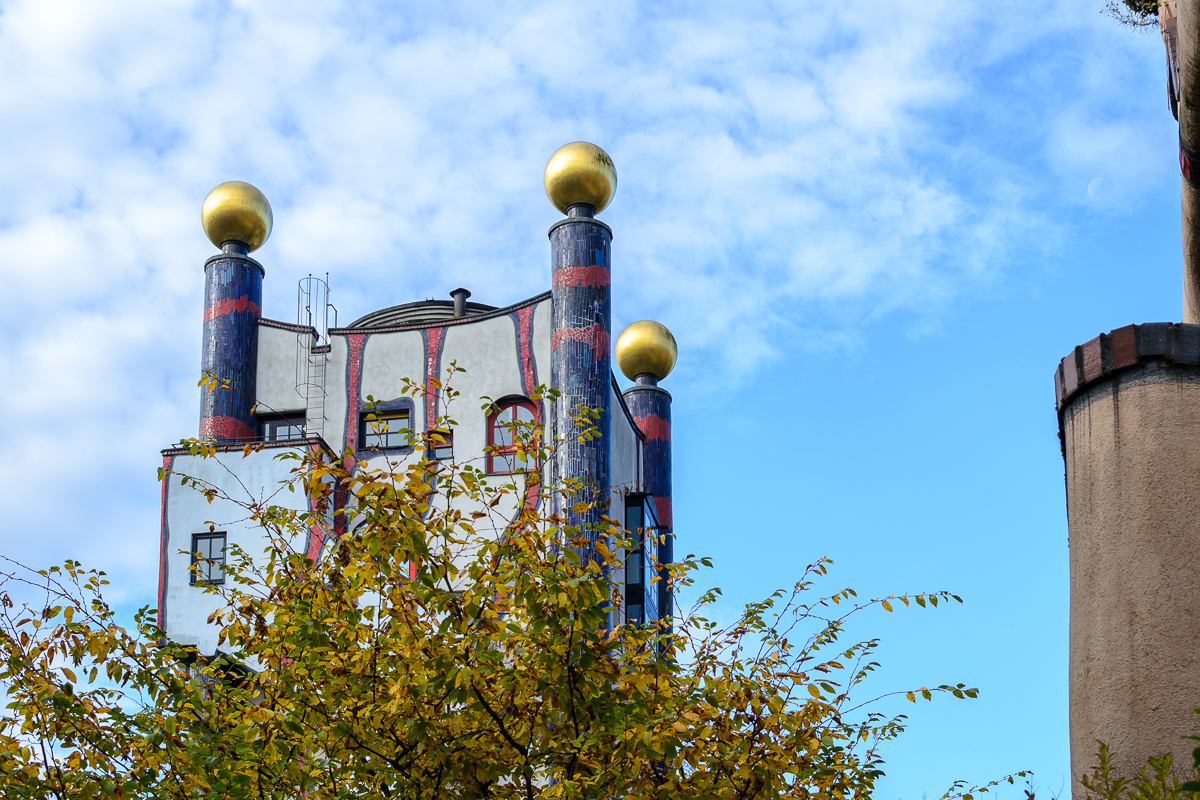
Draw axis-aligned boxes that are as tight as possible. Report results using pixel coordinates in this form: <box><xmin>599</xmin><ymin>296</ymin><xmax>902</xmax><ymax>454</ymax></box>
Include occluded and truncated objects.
<box><xmin>616</xmin><ymin>319</ymin><xmax>679</xmax><ymax>624</ymax></box>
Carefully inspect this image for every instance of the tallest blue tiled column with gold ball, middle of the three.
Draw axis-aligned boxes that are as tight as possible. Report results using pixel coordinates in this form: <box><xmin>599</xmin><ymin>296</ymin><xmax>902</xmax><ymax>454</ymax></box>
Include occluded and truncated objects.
<box><xmin>544</xmin><ymin>142</ymin><xmax>617</xmax><ymax>531</ymax></box>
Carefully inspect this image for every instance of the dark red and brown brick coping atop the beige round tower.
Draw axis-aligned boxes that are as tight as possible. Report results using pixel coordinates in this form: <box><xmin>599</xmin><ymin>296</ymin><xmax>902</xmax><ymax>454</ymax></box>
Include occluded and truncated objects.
<box><xmin>1054</xmin><ymin>323</ymin><xmax>1200</xmax><ymax>414</ymax></box>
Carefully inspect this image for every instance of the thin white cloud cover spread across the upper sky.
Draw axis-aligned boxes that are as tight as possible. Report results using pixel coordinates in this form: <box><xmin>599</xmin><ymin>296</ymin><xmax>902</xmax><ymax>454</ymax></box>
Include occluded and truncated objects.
<box><xmin>0</xmin><ymin>0</ymin><xmax>1180</xmax><ymax>590</ymax></box>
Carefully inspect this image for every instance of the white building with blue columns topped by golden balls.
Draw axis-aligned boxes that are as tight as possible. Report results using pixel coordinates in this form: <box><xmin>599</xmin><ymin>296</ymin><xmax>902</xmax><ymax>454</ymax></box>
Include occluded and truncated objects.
<box><xmin>158</xmin><ymin>142</ymin><xmax>677</xmax><ymax>655</ymax></box>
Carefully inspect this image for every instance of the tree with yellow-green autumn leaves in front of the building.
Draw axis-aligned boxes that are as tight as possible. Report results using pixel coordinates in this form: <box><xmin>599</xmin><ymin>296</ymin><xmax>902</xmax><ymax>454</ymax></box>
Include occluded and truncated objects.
<box><xmin>0</xmin><ymin>376</ymin><xmax>1012</xmax><ymax>800</ymax></box>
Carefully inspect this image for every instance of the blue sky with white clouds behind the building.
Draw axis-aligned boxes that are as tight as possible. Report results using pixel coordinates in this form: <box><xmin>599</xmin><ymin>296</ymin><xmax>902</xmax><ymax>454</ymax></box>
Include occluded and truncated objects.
<box><xmin>0</xmin><ymin>0</ymin><xmax>1184</xmax><ymax>800</ymax></box>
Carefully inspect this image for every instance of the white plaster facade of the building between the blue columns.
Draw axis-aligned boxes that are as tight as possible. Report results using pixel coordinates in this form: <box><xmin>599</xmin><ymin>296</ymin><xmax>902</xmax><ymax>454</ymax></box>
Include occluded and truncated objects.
<box><xmin>160</xmin><ymin>293</ymin><xmax>644</xmax><ymax>654</ymax></box>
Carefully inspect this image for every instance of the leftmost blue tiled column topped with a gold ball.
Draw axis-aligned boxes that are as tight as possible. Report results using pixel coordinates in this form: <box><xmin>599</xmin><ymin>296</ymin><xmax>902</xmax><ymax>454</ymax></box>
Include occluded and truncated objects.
<box><xmin>200</xmin><ymin>181</ymin><xmax>272</xmax><ymax>441</ymax></box>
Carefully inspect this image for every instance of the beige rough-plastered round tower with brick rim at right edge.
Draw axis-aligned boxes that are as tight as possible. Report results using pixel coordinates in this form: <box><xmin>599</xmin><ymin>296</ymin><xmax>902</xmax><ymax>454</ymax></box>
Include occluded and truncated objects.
<box><xmin>1056</xmin><ymin>323</ymin><xmax>1200</xmax><ymax>796</ymax></box>
